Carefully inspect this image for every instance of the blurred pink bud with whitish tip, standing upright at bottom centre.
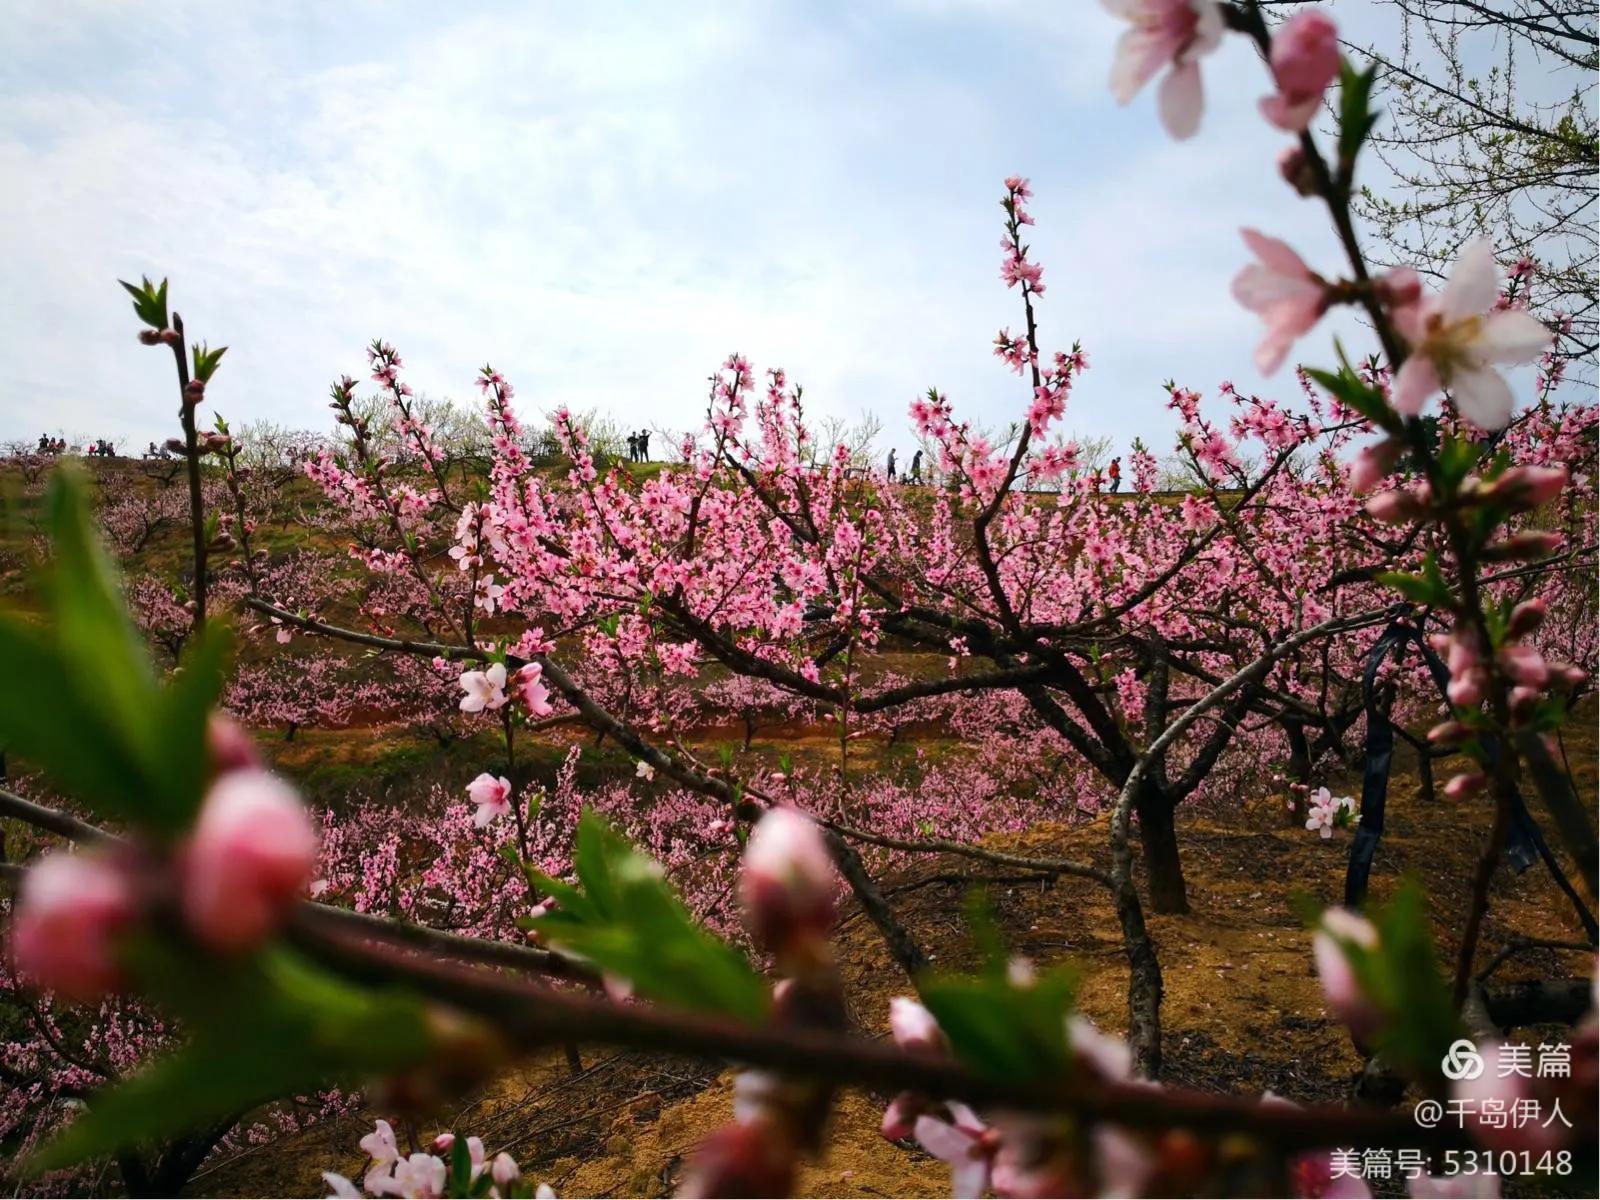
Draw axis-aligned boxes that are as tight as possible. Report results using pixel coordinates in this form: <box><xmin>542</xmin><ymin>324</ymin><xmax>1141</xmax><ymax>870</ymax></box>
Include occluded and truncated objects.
<box><xmin>739</xmin><ymin>808</ymin><xmax>835</xmax><ymax>954</ymax></box>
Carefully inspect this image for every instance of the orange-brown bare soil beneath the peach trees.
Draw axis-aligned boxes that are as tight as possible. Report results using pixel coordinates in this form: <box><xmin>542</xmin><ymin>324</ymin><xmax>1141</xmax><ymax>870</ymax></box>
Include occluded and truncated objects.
<box><xmin>192</xmin><ymin>702</ymin><xmax>1597</xmax><ymax>1197</ymax></box>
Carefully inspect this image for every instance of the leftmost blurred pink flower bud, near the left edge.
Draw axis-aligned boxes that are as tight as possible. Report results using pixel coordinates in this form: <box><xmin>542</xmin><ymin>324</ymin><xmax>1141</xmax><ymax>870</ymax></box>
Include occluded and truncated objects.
<box><xmin>11</xmin><ymin>853</ymin><xmax>136</xmax><ymax>1002</ymax></box>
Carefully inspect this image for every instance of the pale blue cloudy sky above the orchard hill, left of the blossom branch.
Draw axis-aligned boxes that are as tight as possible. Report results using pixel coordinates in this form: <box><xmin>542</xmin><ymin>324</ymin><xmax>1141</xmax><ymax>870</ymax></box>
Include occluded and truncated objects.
<box><xmin>0</xmin><ymin>0</ymin><xmax>1548</xmax><ymax>453</ymax></box>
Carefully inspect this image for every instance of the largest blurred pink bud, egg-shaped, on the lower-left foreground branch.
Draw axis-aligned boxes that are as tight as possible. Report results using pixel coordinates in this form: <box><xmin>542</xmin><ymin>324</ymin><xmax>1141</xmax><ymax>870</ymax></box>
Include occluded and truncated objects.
<box><xmin>182</xmin><ymin>770</ymin><xmax>317</xmax><ymax>950</ymax></box>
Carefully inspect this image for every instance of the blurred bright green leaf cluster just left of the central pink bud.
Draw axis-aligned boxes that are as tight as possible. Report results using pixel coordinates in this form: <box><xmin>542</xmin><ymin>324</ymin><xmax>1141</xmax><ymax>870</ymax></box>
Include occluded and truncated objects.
<box><xmin>517</xmin><ymin>810</ymin><xmax>768</xmax><ymax>1022</ymax></box>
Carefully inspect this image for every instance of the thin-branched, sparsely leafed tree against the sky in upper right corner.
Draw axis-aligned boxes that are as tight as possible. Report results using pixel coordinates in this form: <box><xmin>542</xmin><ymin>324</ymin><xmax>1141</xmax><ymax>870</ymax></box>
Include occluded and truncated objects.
<box><xmin>1274</xmin><ymin>0</ymin><xmax>1600</xmax><ymax>381</ymax></box>
